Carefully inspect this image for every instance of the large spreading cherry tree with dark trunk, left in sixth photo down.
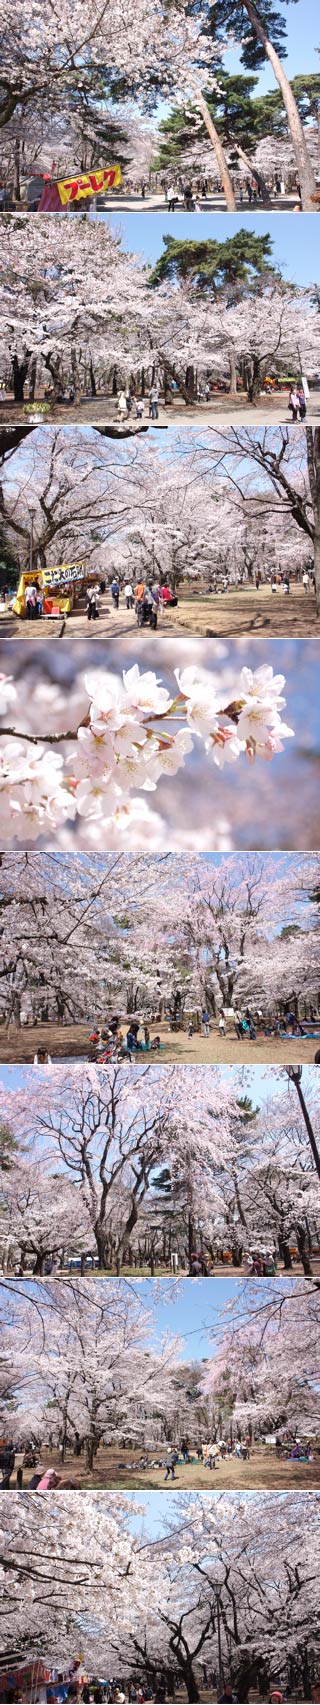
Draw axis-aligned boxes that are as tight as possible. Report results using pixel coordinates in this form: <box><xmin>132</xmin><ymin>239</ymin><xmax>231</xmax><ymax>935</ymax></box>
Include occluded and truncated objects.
<box><xmin>0</xmin><ymin>1064</ymin><xmax>237</xmax><ymax>1272</ymax></box>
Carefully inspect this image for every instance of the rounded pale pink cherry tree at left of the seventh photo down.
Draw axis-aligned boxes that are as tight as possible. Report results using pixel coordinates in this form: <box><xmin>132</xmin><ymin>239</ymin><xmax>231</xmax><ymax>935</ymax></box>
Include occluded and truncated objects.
<box><xmin>0</xmin><ymin>1279</ymin><xmax>184</xmax><ymax>1471</ymax></box>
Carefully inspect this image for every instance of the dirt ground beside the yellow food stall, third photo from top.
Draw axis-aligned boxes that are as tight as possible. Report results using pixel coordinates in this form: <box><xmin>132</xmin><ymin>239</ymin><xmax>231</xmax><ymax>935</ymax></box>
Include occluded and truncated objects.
<box><xmin>0</xmin><ymin>585</ymin><xmax>320</xmax><ymax>644</ymax></box>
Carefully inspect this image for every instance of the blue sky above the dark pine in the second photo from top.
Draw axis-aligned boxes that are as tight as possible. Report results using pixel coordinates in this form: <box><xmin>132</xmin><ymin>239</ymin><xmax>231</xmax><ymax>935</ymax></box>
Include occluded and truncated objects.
<box><xmin>100</xmin><ymin>211</ymin><xmax>320</xmax><ymax>285</ymax></box>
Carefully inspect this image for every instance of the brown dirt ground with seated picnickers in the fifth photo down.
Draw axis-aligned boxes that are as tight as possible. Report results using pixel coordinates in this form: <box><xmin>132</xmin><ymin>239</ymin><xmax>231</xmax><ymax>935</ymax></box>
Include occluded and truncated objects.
<box><xmin>0</xmin><ymin>1020</ymin><xmax>320</xmax><ymax>1066</ymax></box>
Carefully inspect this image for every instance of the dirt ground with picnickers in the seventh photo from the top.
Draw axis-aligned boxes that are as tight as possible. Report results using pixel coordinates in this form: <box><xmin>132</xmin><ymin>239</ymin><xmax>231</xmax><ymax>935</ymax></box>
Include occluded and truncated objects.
<box><xmin>12</xmin><ymin>1446</ymin><xmax>320</xmax><ymax>1492</ymax></box>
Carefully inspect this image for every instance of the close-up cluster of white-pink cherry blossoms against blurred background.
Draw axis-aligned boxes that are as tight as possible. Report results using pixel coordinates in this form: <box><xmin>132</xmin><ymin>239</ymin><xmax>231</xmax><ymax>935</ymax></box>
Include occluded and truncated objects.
<box><xmin>0</xmin><ymin>663</ymin><xmax>293</xmax><ymax>841</ymax></box>
